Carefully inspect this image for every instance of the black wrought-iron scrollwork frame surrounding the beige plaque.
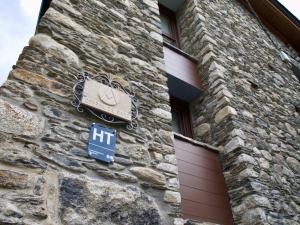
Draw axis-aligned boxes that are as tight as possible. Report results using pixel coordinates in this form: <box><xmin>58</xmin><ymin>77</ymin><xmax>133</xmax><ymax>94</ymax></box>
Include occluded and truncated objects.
<box><xmin>72</xmin><ymin>72</ymin><xmax>138</xmax><ymax>130</ymax></box>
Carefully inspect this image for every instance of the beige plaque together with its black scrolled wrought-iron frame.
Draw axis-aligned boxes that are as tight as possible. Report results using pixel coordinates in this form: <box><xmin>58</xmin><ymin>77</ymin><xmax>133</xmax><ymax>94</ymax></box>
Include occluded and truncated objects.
<box><xmin>72</xmin><ymin>72</ymin><xmax>138</xmax><ymax>130</ymax></box>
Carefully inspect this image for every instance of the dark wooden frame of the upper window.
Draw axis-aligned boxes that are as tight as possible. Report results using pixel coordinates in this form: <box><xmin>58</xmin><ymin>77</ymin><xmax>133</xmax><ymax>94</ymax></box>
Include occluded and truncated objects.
<box><xmin>158</xmin><ymin>4</ymin><xmax>180</xmax><ymax>48</ymax></box>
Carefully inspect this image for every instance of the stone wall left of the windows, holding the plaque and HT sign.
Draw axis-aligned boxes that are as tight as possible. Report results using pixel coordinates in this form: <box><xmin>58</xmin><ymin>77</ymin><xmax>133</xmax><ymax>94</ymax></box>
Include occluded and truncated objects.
<box><xmin>0</xmin><ymin>0</ymin><xmax>180</xmax><ymax>225</ymax></box>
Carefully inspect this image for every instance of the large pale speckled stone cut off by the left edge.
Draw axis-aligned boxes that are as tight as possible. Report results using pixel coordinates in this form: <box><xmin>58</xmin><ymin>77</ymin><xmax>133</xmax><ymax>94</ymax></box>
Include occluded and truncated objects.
<box><xmin>0</xmin><ymin>99</ymin><xmax>45</xmax><ymax>137</ymax></box>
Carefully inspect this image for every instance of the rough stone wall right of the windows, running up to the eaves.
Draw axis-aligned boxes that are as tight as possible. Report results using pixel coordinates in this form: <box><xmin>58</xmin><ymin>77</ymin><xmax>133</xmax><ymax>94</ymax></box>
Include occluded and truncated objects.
<box><xmin>177</xmin><ymin>0</ymin><xmax>300</xmax><ymax>224</ymax></box>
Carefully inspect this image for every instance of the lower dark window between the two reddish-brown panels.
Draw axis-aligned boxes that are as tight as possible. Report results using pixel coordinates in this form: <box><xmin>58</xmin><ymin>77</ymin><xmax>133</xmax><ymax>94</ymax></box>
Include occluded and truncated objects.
<box><xmin>171</xmin><ymin>96</ymin><xmax>193</xmax><ymax>137</ymax></box>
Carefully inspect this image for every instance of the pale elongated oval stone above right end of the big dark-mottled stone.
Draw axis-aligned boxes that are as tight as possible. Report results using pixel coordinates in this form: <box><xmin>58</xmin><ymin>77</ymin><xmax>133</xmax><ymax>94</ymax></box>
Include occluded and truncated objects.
<box><xmin>130</xmin><ymin>167</ymin><xmax>166</xmax><ymax>185</ymax></box>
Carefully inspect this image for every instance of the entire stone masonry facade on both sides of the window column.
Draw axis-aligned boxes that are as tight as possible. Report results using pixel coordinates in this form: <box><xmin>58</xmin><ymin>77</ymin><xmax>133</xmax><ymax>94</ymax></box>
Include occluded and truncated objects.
<box><xmin>0</xmin><ymin>0</ymin><xmax>300</xmax><ymax>225</ymax></box>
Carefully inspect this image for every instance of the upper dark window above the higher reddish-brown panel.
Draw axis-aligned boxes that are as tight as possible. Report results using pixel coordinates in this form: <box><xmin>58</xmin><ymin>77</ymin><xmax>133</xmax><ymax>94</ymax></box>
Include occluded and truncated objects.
<box><xmin>159</xmin><ymin>5</ymin><xmax>179</xmax><ymax>48</ymax></box>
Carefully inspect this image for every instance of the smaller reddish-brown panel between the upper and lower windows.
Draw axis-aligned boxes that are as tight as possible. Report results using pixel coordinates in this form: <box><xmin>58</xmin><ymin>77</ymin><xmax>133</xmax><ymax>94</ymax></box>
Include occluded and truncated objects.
<box><xmin>163</xmin><ymin>46</ymin><xmax>201</xmax><ymax>89</ymax></box>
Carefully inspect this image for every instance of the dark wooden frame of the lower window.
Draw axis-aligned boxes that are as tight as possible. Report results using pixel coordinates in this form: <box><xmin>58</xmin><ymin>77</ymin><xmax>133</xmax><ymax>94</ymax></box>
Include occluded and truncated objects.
<box><xmin>170</xmin><ymin>96</ymin><xmax>193</xmax><ymax>138</ymax></box>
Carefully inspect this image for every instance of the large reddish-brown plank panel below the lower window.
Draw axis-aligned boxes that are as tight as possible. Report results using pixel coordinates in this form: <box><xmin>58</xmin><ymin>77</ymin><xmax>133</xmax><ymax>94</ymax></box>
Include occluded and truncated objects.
<box><xmin>174</xmin><ymin>138</ymin><xmax>234</xmax><ymax>225</ymax></box>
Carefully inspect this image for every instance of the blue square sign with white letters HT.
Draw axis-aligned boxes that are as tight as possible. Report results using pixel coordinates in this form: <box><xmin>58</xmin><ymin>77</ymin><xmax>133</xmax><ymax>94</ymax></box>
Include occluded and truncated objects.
<box><xmin>88</xmin><ymin>123</ymin><xmax>116</xmax><ymax>163</ymax></box>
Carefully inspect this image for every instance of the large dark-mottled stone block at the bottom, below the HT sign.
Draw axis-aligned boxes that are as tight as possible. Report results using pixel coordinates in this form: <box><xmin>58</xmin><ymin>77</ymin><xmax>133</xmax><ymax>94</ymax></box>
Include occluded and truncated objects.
<box><xmin>59</xmin><ymin>176</ymin><xmax>161</xmax><ymax>225</ymax></box>
